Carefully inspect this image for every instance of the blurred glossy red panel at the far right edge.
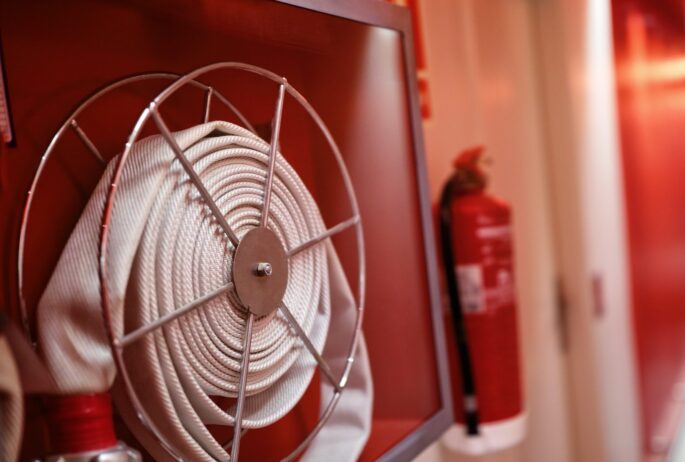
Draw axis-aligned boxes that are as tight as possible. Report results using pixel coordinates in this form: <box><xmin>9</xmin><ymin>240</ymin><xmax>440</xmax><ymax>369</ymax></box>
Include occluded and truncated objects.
<box><xmin>613</xmin><ymin>0</ymin><xmax>685</xmax><ymax>453</ymax></box>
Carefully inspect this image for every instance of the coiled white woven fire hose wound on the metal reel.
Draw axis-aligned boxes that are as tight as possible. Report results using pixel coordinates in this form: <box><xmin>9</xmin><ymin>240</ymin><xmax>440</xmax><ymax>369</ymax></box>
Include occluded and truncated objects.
<box><xmin>38</xmin><ymin>122</ymin><xmax>372</xmax><ymax>461</ymax></box>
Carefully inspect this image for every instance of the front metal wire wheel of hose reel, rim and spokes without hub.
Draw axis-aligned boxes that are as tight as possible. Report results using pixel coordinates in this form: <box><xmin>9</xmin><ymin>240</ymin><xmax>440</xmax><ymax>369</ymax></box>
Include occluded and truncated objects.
<box><xmin>99</xmin><ymin>63</ymin><xmax>365</xmax><ymax>461</ymax></box>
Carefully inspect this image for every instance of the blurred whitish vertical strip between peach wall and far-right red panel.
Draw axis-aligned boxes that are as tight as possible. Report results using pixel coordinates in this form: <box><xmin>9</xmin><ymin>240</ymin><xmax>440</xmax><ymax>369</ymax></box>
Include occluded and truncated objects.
<box><xmin>536</xmin><ymin>0</ymin><xmax>641</xmax><ymax>462</ymax></box>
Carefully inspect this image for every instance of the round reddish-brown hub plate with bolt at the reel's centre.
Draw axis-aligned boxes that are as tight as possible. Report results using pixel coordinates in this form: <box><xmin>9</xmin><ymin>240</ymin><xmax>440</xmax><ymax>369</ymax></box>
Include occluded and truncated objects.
<box><xmin>232</xmin><ymin>227</ymin><xmax>288</xmax><ymax>316</ymax></box>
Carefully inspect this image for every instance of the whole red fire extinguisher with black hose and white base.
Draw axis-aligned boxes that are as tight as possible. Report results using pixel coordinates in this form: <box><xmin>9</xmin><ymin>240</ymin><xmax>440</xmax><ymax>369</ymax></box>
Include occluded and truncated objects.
<box><xmin>439</xmin><ymin>146</ymin><xmax>526</xmax><ymax>454</ymax></box>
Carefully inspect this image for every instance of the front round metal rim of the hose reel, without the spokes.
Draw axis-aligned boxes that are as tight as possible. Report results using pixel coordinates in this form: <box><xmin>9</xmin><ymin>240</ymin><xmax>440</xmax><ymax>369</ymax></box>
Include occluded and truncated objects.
<box><xmin>99</xmin><ymin>62</ymin><xmax>366</xmax><ymax>461</ymax></box>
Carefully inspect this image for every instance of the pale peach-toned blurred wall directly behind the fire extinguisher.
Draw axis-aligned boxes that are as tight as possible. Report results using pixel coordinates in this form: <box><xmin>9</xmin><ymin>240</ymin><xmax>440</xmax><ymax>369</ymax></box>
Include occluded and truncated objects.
<box><xmin>412</xmin><ymin>0</ymin><xmax>574</xmax><ymax>462</ymax></box>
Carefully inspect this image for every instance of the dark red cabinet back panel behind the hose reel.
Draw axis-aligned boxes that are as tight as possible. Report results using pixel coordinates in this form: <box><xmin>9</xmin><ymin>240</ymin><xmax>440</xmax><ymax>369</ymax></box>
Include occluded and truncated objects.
<box><xmin>0</xmin><ymin>0</ymin><xmax>440</xmax><ymax>461</ymax></box>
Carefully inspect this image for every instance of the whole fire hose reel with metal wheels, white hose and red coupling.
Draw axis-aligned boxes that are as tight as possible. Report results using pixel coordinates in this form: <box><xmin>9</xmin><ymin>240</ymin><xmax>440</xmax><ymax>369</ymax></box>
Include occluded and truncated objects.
<box><xmin>14</xmin><ymin>63</ymin><xmax>372</xmax><ymax>462</ymax></box>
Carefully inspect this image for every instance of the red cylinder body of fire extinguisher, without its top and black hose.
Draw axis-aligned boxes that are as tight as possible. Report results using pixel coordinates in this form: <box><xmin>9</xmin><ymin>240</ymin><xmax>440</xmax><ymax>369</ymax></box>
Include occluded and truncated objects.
<box><xmin>450</xmin><ymin>189</ymin><xmax>523</xmax><ymax>424</ymax></box>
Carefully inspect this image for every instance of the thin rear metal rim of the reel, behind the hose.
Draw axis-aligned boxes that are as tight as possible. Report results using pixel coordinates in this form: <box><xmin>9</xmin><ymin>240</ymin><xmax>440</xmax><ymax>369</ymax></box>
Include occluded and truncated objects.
<box><xmin>17</xmin><ymin>72</ymin><xmax>256</xmax><ymax>346</ymax></box>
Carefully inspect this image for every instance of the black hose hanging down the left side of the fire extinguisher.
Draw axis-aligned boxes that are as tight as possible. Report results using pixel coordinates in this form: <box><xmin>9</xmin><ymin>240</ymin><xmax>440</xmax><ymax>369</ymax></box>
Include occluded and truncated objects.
<box><xmin>439</xmin><ymin>176</ymin><xmax>479</xmax><ymax>435</ymax></box>
